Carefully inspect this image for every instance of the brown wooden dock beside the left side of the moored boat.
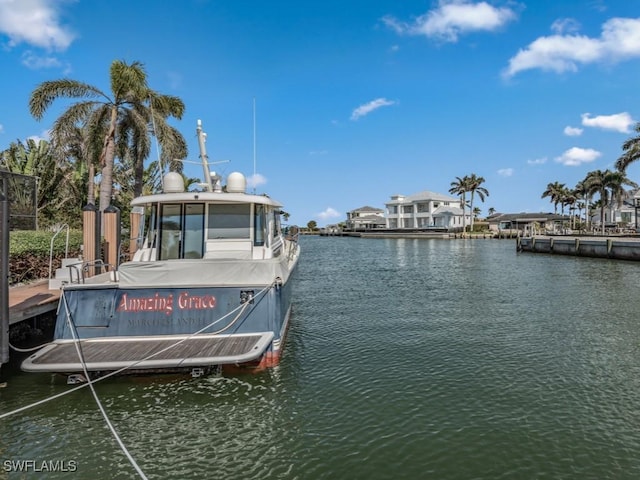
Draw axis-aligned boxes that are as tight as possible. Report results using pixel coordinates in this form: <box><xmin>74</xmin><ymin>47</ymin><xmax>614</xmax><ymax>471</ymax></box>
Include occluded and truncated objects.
<box><xmin>9</xmin><ymin>280</ymin><xmax>60</xmax><ymax>325</ymax></box>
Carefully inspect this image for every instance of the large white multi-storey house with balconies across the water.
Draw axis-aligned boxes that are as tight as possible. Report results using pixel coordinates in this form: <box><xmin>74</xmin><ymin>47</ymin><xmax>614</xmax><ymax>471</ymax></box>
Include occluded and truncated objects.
<box><xmin>385</xmin><ymin>191</ymin><xmax>471</xmax><ymax>230</ymax></box>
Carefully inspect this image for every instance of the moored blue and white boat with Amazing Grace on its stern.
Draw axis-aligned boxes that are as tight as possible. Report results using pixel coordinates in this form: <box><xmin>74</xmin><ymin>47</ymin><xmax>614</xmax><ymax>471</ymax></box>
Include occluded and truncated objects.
<box><xmin>21</xmin><ymin>121</ymin><xmax>300</xmax><ymax>380</ymax></box>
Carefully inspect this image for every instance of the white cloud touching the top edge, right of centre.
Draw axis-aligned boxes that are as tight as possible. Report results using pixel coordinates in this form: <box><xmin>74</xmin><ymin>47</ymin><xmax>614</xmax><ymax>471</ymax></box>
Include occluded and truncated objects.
<box><xmin>382</xmin><ymin>0</ymin><xmax>516</xmax><ymax>42</ymax></box>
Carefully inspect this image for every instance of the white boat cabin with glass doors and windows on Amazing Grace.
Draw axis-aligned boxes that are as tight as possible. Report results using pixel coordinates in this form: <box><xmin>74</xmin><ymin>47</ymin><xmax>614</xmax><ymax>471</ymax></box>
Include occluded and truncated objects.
<box><xmin>132</xmin><ymin>174</ymin><xmax>283</xmax><ymax>262</ymax></box>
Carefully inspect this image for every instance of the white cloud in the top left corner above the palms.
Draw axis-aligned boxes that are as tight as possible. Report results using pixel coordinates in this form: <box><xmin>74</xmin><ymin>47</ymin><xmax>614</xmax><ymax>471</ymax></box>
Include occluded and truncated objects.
<box><xmin>0</xmin><ymin>0</ymin><xmax>74</xmax><ymax>50</ymax></box>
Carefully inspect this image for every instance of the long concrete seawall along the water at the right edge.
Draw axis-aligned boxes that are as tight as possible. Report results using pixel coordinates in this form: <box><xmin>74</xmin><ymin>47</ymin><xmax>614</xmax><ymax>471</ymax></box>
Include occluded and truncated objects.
<box><xmin>516</xmin><ymin>236</ymin><xmax>640</xmax><ymax>261</ymax></box>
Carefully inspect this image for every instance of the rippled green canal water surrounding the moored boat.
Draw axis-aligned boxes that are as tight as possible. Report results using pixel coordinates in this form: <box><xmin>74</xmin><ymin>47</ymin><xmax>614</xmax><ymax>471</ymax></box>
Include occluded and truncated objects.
<box><xmin>0</xmin><ymin>237</ymin><xmax>640</xmax><ymax>480</ymax></box>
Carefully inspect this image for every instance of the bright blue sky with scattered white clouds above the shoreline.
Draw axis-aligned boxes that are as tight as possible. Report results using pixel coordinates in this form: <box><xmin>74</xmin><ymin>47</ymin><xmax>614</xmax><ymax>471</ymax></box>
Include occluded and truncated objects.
<box><xmin>0</xmin><ymin>0</ymin><xmax>640</xmax><ymax>226</ymax></box>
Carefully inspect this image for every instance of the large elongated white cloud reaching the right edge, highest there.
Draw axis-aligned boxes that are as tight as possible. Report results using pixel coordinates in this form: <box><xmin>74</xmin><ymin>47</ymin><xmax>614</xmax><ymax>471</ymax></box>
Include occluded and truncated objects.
<box><xmin>503</xmin><ymin>18</ymin><xmax>640</xmax><ymax>77</ymax></box>
